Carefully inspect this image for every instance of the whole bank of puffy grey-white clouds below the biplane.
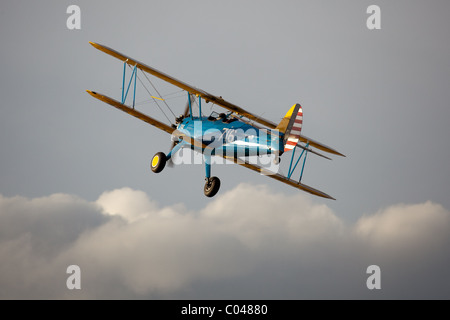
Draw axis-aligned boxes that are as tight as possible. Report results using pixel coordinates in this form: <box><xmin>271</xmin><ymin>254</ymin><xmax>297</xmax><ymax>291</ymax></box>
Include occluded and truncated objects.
<box><xmin>0</xmin><ymin>184</ymin><xmax>450</xmax><ymax>299</ymax></box>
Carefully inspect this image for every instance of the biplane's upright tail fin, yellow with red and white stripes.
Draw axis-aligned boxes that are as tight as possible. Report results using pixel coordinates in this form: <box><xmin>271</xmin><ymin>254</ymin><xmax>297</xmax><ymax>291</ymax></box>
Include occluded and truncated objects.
<box><xmin>276</xmin><ymin>103</ymin><xmax>303</xmax><ymax>152</ymax></box>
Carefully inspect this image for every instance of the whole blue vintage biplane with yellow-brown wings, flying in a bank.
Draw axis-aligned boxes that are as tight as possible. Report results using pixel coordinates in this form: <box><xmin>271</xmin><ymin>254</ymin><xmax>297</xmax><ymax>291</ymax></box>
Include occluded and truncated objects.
<box><xmin>87</xmin><ymin>42</ymin><xmax>344</xmax><ymax>199</ymax></box>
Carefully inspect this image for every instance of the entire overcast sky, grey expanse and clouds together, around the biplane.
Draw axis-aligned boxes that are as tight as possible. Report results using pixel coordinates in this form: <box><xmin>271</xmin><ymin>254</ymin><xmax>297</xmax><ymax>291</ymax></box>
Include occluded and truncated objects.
<box><xmin>0</xmin><ymin>0</ymin><xmax>450</xmax><ymax>299</ymax></box>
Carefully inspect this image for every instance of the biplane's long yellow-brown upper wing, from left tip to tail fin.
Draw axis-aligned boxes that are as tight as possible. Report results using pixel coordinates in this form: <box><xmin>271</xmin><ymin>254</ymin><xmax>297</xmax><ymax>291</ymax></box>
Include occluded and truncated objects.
<box><xmin>89</xmin><ymin>42</ymin><xmax>276</xmax><ymax>129</ymax></box>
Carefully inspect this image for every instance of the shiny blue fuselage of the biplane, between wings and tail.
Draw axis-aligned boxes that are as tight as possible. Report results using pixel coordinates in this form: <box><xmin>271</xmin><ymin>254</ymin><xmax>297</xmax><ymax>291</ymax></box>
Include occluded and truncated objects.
<box><xmin>177</xmin><ymin>114</ymin><xmax>283</xmax><ymax>157</ymax></box>
